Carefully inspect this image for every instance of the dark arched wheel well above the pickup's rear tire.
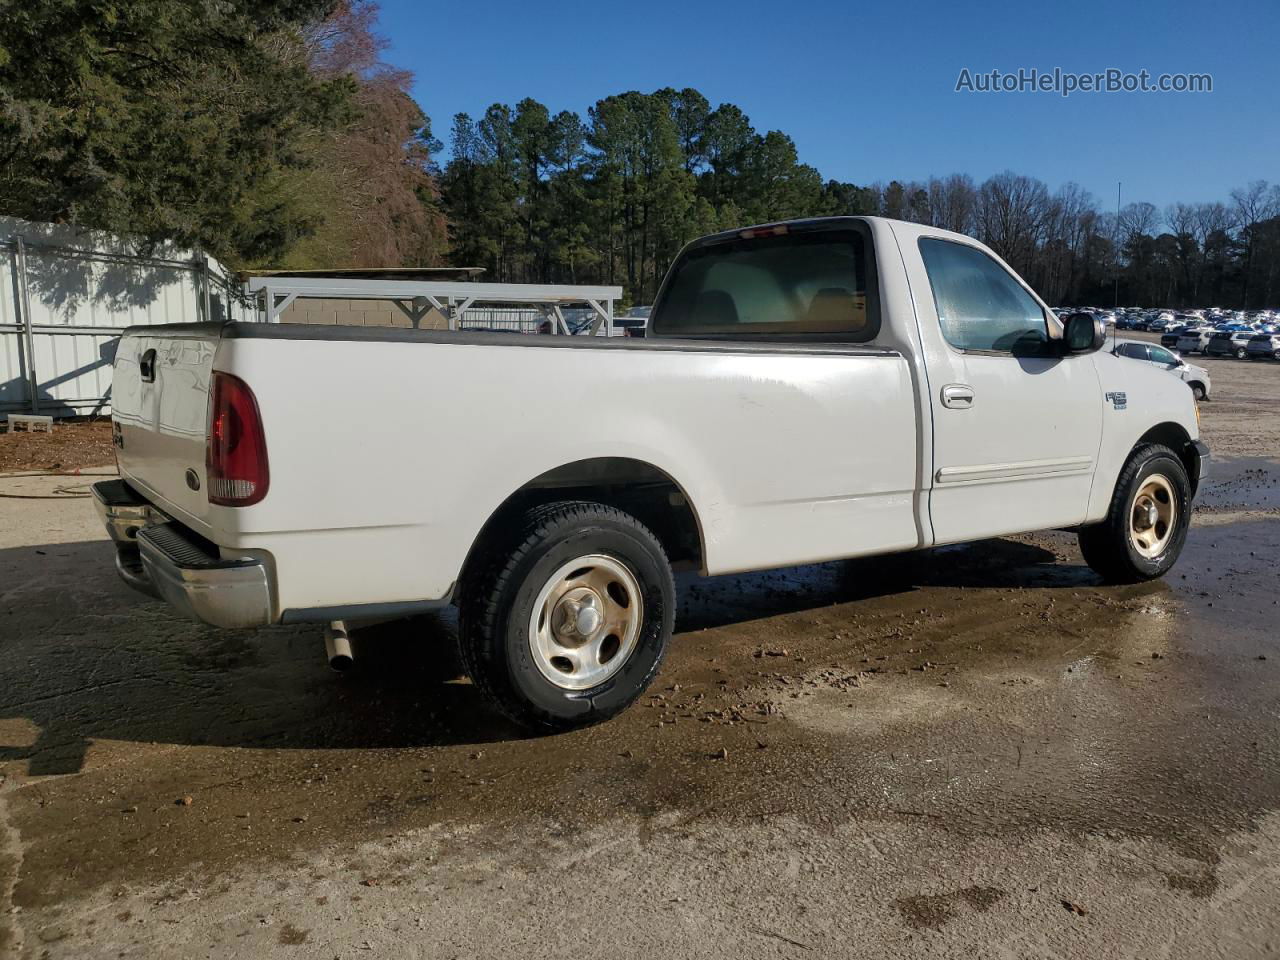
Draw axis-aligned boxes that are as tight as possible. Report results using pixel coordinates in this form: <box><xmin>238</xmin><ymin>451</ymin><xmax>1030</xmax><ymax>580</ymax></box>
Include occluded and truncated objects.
<box><xmin>467</xmin><ymin>457</ymin><xmax>704</xmax><ymax>570</ymax></box>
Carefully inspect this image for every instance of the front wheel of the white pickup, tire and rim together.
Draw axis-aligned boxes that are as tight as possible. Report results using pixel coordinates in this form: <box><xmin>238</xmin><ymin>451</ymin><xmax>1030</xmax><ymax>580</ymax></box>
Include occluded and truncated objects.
<box><xmin>1079</xmin><ymin>443</ymin><xmax>1192</xmax><ymax>584</ymax></box>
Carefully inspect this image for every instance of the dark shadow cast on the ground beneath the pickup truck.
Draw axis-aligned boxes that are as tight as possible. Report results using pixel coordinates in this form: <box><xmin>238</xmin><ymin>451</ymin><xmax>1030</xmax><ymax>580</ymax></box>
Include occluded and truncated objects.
<box><xmin>0</xmin><ymin>540</ymin><xmax>1092</xmax><ymax>776</ymax></box>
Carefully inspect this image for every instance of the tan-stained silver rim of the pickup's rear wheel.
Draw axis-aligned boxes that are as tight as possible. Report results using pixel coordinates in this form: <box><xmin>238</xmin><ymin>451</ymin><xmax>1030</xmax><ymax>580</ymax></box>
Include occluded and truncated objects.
<box><xmin>529</xmin><ymin>553</ymin><xmax>644</xmax><ymax>690</ymax></box>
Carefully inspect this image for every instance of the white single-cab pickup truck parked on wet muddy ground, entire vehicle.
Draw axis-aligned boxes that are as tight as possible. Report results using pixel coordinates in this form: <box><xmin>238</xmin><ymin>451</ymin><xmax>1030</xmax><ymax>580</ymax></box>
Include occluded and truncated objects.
<box><xmin>95</xmin><ymin>218</ymin><xmax>1208</xmax><ymax>730</ymax></box>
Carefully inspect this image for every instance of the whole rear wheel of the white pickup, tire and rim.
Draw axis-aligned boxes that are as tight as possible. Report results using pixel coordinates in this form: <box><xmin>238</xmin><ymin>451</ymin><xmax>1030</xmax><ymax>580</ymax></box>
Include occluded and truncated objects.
<box><xmin>458</xmin><ymin>500</ymin><xmax>676</xmax><ymax>732</ymax></box>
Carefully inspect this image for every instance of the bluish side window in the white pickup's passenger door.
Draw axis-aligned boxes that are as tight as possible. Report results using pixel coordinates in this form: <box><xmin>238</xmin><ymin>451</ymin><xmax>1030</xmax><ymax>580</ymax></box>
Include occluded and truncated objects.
<box><xmin>920</xmin><ymin>237</ymin><xmax>1048</xmax><ymax>356</ymax></box>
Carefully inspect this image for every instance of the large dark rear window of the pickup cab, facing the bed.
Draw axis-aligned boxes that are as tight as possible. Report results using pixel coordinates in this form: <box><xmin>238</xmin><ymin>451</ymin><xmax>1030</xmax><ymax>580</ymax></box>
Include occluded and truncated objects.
<box><xmin>649</xmin><ymin>221</ymin><xmax>881</xmax><ymax>343</ymax></box>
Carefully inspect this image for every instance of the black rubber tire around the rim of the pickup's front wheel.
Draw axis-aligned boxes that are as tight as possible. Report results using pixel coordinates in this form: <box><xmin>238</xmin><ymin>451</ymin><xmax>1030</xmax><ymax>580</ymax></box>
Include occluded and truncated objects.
<box><xmin>1079</xmin><ymin>443</ymin><xmax>1192</xmax><ymax>584</ymax></box>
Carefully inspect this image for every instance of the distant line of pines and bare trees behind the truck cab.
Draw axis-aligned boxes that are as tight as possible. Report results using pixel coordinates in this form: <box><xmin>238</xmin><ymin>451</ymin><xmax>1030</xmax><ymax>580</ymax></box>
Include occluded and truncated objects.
<box><xmin>443</xmin><ymin>87</ymin><xmax>1280</xmax><ymax>306</ymax></box>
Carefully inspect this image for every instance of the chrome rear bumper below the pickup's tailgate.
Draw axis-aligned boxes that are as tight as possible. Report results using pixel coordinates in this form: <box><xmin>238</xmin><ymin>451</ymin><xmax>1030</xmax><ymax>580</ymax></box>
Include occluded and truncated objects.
<box><xmin>93</xmin><ymin>480</ymin><xmax>275</xmax><ymax>627</ymax></box>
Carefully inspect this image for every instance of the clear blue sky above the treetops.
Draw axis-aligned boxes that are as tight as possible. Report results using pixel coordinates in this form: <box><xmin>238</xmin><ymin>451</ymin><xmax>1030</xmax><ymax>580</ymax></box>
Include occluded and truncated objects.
<box><xmin>380</xmin><ymin>0</ymin><xmax>1280</xmax><ymax>209</ymax></box>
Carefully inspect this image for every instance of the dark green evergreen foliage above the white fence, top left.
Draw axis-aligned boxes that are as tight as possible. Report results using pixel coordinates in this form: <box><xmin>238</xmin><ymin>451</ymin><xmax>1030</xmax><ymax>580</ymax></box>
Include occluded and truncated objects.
<box><xmin>0</xmin><ymin>0</ymin><xmax>353</xmax><ymax>261</ymax></box>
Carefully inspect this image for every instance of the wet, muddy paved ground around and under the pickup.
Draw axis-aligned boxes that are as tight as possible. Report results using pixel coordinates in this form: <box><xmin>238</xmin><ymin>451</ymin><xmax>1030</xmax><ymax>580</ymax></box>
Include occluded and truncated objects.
<box><xmin>0</xmin><ymin>343</ymin><xmax>1280</xmax><ymax>959</ymax></box>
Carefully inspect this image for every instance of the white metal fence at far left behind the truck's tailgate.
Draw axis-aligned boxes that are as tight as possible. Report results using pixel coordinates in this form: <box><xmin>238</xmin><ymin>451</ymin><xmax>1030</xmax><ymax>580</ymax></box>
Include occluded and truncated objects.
<box><xmin>0</xmin><ymin>218</ymin><xmax>247</xmax><ymax>417</ymax></box>
